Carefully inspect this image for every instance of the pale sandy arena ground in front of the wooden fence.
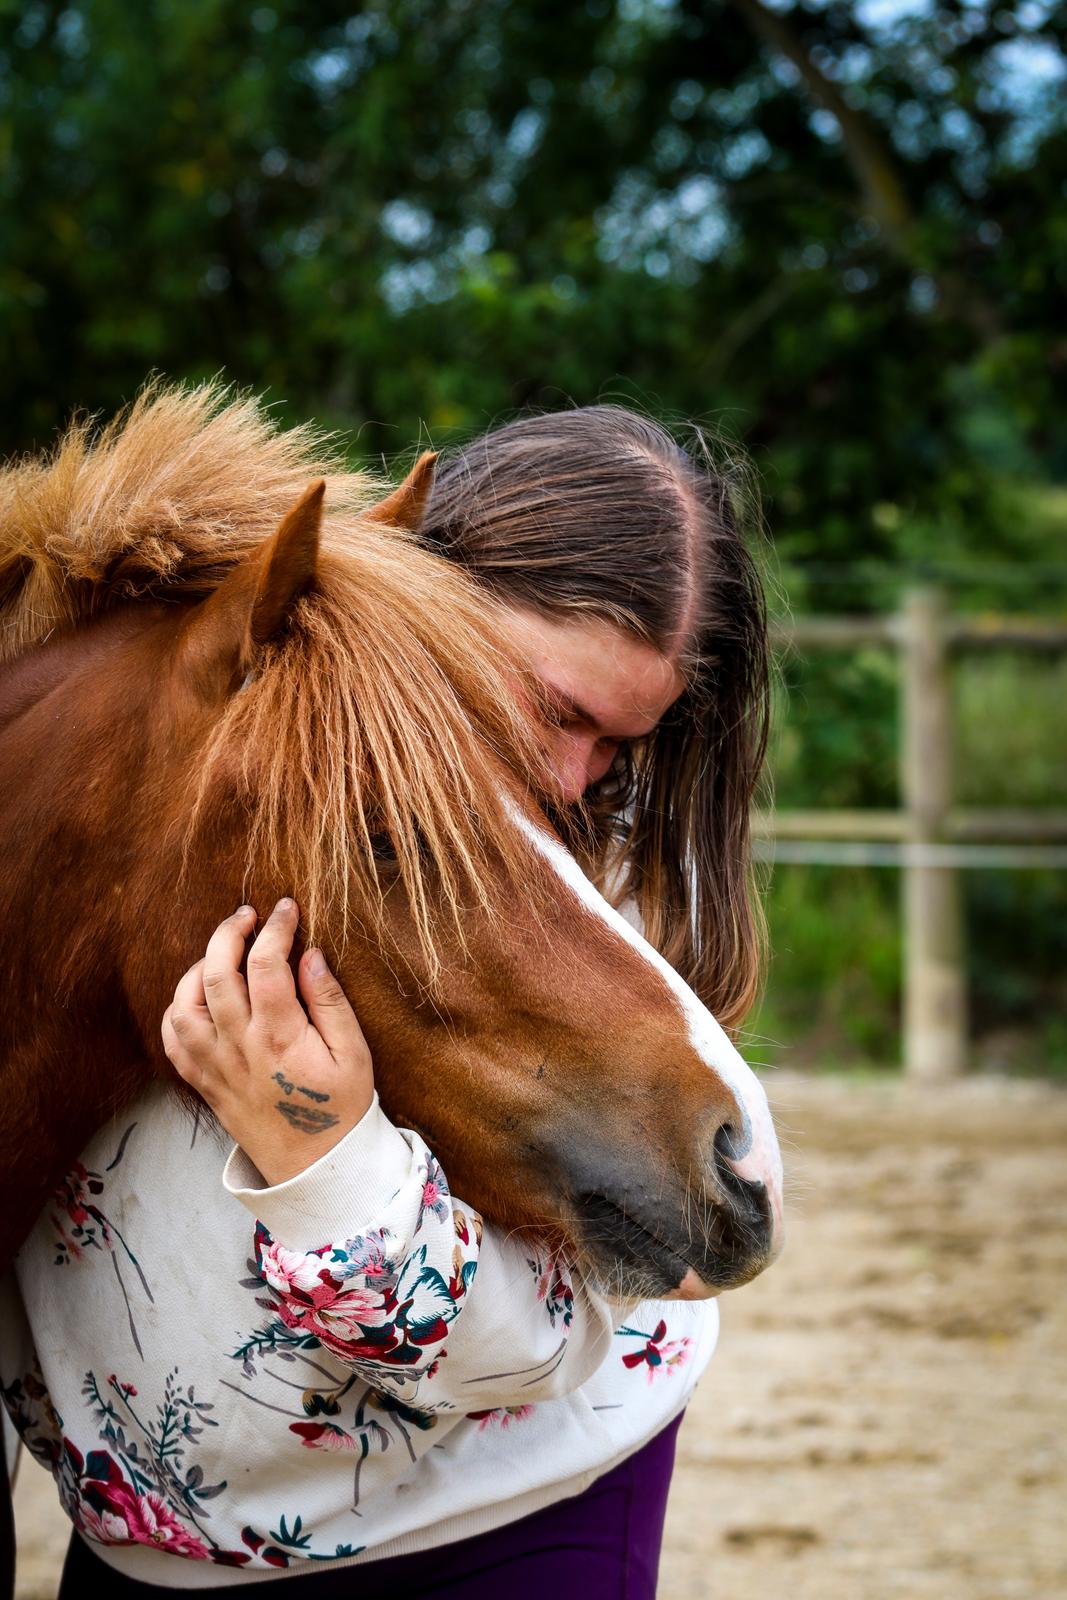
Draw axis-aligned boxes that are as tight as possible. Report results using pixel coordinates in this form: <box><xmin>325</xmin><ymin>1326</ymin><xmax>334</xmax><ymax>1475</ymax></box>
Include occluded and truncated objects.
<box><xmin>10</xmin><ymin>1074</ymin><xmax>1067</xmax><ymax>1600</ymax></box>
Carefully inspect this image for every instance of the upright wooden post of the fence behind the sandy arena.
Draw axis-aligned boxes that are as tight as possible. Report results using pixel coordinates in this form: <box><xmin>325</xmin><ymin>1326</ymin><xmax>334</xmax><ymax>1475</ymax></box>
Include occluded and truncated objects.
<box><xmin>901</xmin><ymin>589</ymin><xmax>968</xmax><ymax>1082</ymax></box>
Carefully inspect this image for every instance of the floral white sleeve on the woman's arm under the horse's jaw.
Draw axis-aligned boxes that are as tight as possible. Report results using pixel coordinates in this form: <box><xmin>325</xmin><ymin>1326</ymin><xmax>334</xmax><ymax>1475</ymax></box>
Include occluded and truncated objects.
<box><xmin>222</xmin><ymin>1094</ymin><xmax>638</xmax><ymax>1411</ymax></box>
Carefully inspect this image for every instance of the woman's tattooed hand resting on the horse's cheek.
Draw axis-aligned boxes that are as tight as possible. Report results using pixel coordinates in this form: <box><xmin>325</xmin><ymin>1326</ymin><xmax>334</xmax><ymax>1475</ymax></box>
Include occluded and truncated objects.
<box><xmin>163</xmin><ymin>899</ymin><xmax>374</xmax><ymax>1186</ymax></box>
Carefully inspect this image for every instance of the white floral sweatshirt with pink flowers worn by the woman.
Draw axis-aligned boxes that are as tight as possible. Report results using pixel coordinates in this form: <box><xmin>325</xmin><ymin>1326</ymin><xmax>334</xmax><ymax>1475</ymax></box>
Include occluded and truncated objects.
<box><xmin>0</xmin><ymin>1088</ymin><xmax>718</xmax><ymax>1589</ymax></box>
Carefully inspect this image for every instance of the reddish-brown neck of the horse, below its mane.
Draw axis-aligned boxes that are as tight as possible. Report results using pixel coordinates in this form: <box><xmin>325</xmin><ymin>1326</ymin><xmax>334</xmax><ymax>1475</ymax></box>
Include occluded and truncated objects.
<box><xmin>0</xmin><ymin>608</ymin><xmax>233</xmax><ymax>1258</ymax></box>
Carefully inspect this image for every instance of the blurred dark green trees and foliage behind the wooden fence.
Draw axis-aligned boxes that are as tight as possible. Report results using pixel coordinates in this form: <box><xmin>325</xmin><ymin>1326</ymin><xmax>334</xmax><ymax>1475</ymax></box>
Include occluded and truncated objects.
<box><xmin>0</xmin><ymin>0</ymin><xmax>1067</xmax><ymax>1074</ymax></box>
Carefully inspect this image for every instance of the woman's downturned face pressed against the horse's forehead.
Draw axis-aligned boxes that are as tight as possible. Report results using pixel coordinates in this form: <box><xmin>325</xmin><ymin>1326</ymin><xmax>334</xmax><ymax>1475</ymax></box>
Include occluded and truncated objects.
<box><xmin>507</xmin><ymin>606</ymin><xmax>685</xmax><ymax>802</ymax></box>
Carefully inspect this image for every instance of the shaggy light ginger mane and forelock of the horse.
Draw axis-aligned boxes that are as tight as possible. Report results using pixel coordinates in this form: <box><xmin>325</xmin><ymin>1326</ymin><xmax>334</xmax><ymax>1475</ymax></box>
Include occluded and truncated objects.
<box><xmin>0</xmin><ymin>379</ymin><xmax>542</xmax><ymax>974</ymax></box>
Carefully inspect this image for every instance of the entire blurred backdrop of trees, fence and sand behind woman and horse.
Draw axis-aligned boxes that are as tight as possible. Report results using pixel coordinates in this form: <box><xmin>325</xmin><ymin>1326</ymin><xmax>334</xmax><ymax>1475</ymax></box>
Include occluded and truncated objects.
<box><xmin>0</xmin><ymin>0</ymin><xmax>1067</xmax><ymax>1600</ymax></box>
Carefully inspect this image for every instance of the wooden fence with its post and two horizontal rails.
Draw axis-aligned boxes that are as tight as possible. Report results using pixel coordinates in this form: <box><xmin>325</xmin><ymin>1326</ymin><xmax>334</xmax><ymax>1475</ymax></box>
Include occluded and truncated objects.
<box><xmin>764</xmin><ymin>587</ymin><xmax>1067</xmax><ymax>1082</ymax></box>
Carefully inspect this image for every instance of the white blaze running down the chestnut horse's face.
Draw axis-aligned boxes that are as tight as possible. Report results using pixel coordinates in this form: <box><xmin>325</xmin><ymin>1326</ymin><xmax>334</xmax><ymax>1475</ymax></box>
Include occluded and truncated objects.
<box><xmin>518</xmin><ymin>814</ymin><xmax>782</xmax><ymax>1253</ymax></box>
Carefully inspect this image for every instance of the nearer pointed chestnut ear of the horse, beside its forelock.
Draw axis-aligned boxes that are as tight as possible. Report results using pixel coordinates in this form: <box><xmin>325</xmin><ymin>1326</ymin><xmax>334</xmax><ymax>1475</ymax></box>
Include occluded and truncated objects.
<box><xmin>182</xmin><ymin>478</ymin><xmax>326</xmax><ymax>698</ymax></box>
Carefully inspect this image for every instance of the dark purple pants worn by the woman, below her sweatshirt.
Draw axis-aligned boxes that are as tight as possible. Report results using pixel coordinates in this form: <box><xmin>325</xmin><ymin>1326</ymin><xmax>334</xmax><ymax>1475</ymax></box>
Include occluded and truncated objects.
<box><xmin>59</xmin><ymin>1416</ymin><xmax>681</xmax><ymax>1600</ymax></box>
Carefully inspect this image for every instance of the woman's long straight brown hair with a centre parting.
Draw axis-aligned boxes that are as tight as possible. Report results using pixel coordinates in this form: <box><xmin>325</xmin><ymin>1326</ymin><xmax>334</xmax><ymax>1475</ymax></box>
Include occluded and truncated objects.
<box><xmin>422</xmin><ymin>405</ymin><xmax>769</xmax><ymax>1030</ymax></box>
